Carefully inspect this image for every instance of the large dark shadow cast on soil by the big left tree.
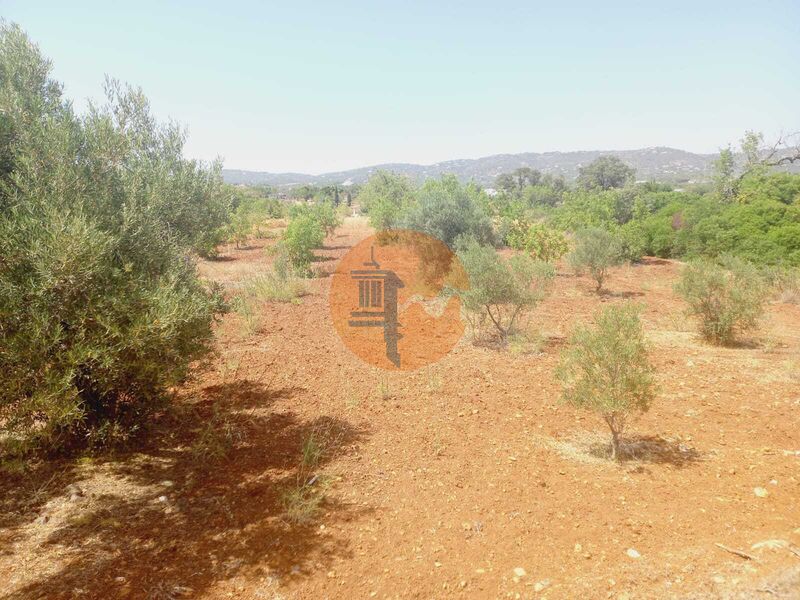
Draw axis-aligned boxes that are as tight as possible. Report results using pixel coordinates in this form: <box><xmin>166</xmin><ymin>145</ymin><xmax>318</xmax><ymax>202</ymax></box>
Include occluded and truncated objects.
<box><xmin>3</xmin><ymin>380</ymin><xmax>370</xmax><ymax>600</ymax></box>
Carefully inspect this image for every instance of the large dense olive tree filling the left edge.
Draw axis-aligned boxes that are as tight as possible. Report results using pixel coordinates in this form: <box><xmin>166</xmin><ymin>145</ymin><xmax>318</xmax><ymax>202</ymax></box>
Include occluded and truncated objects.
<box><xmin>0</xmin><ymin>23</ymin><xmax>227</xmax><ymax>453</ymax></box>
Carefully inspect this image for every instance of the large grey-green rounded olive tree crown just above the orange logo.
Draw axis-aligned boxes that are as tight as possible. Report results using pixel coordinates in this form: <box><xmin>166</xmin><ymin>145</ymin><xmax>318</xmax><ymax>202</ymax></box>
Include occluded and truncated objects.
<box><xmin>401</xmin><ymin>175</ymin><xmax>495</xmax><ymax>248</ymax></box>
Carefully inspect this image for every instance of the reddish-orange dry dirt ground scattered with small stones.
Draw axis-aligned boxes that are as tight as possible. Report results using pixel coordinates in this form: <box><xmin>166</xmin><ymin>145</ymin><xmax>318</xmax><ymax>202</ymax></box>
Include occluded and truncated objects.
<box><xmin>0</xmin><ymin>218</ymin><xmax>800</xmax><ymax>600</ymax></box>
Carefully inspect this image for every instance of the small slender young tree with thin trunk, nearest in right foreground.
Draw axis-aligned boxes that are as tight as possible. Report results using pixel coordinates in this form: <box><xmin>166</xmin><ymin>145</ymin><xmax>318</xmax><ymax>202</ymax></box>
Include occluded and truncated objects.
<box><xmin>556</xmin><ymin>304</ymin><xmax>655</xmax><ymax>459</ymax></box>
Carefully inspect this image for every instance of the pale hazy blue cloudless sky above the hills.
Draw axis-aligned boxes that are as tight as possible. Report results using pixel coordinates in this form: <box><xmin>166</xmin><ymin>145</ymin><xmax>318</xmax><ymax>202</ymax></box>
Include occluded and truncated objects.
<box><xmin>0</xmin><ymin>0</ymin><xmax>800</xmax><ymax>173</ymax></box>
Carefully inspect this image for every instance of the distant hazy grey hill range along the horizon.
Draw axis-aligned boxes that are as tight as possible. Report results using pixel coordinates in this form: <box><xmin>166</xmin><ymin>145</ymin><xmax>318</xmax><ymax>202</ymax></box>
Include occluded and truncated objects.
<box><xmin>222</xmin><ymin>147</ymin><xmax>717</xmax><ymax>186</ymax></box>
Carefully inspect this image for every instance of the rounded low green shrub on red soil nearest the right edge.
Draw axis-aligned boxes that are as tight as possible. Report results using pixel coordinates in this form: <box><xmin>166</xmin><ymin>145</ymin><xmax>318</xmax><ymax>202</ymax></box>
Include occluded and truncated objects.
<box><xmin>675</xmin><ymin>257</ymin><xmax>769</xmax><ymax>344</ymax></box>
